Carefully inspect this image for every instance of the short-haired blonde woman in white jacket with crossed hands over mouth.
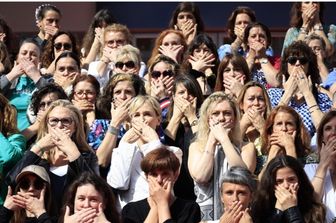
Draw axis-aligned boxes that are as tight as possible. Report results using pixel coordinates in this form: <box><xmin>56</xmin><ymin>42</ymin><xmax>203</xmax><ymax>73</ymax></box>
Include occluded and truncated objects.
<box><xmin>107</xmin><ymin>95</ymin><xmax>182</xmax><ymax>208</ymax></box>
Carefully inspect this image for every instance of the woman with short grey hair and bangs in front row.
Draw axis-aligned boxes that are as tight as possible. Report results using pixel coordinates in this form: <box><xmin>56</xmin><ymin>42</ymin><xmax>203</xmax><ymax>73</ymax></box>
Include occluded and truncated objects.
<box><xmin>204</xmin><ymin>166</ymin><xmax>258</xmax><ymax>223</ymax></box>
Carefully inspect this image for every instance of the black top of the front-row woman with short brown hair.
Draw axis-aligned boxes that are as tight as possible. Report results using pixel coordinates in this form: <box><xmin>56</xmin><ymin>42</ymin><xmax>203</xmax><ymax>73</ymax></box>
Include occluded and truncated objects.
<box><xmin>121</xmin><ymin>198</ymin><xmax>201</xmax><ymax>223</ymax></box>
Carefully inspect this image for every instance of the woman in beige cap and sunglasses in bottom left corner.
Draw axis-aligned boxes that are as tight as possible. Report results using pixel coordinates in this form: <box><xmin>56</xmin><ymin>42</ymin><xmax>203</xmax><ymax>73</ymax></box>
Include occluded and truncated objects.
<box><xmin>0</xmin><ymin>165</ymin><xmax>52</xmax><ymax>223</ymax></box>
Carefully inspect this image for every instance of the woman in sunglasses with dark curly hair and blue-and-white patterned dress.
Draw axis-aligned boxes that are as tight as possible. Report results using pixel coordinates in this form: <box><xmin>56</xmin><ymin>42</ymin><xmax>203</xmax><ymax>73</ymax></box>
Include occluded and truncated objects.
<box><xmin>268</xmin><ymin>41</ymin><xmax>332</xmax><ymax>136</ymax></box>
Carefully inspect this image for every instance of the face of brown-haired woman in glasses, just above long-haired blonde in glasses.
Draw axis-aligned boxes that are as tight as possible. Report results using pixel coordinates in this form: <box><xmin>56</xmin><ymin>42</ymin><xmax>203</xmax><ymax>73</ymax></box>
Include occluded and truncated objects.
<box><xmin>74</xmin><ymin>81</ymin><xmax>97</xmax><ymax>103</ymax></box>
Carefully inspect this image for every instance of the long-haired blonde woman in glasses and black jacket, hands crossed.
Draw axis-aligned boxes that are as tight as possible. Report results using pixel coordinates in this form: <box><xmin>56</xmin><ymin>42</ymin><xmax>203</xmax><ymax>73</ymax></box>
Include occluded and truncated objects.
<box><xmin>7</xmin><ymin>100</ymin><xmax>99</xmax><ymax>216</ymax></box>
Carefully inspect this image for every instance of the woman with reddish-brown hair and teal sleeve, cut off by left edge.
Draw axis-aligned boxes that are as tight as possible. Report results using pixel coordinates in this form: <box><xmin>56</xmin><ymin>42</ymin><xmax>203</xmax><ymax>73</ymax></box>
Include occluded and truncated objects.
<box><xmin>0</xmin><ymin>94</ymin><xmax>26</xmax><ymax>205</ymax></box>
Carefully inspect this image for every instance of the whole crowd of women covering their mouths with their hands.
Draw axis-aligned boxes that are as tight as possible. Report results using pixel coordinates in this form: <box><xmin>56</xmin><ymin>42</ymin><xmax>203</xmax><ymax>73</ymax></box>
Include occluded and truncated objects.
<box><xmin>0</xmin><ymin>2</ymin><xmax>336</xmax><ymax>223</ymax></box>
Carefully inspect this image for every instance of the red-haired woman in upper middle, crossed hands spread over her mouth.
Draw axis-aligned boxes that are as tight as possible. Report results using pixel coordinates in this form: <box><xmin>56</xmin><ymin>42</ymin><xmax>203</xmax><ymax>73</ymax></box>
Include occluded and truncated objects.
<box><xmin>148</xmin><ymin>29</ymin><xmax>187</xmax><ymax>64</ymax></box>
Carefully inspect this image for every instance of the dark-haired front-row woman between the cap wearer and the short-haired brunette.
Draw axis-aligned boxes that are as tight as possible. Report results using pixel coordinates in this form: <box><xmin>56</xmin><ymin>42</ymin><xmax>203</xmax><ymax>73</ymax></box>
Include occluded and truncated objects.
<box><xmin>59</xmin><ymin>172</ymin><xmax>121</xmax><ymax>223</ymax></box>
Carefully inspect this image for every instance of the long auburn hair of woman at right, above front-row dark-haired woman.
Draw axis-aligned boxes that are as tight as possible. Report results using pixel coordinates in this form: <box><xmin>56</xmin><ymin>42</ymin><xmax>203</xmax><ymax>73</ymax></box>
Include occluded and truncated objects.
<box><xmin>261</xmin><ymin>105</ymin><xmax>311</xmax><ymax>158</ymax></box>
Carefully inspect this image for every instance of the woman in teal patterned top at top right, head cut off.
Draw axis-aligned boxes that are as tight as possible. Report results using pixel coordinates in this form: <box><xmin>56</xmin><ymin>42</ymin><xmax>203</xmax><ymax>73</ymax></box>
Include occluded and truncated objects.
<box><xmin>282</xmin><ymin>2</ymin><xmax>336</xmax><ymax>56</ymax></box>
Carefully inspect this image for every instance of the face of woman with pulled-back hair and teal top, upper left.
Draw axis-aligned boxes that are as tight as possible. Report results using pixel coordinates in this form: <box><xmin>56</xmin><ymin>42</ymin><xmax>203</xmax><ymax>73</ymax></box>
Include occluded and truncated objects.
<box><xmin>17</xmin><ymin>43</ymin><xmax>40</xmax><ymax>66</ymax></box>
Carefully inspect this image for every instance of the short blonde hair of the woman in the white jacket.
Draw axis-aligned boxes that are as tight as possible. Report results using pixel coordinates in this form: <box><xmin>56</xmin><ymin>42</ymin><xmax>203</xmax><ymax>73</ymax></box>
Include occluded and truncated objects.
<box><xmin>128</xmin><ymin>95</ymin><xmax>161</xmax><ymax>121</ymax></box>
